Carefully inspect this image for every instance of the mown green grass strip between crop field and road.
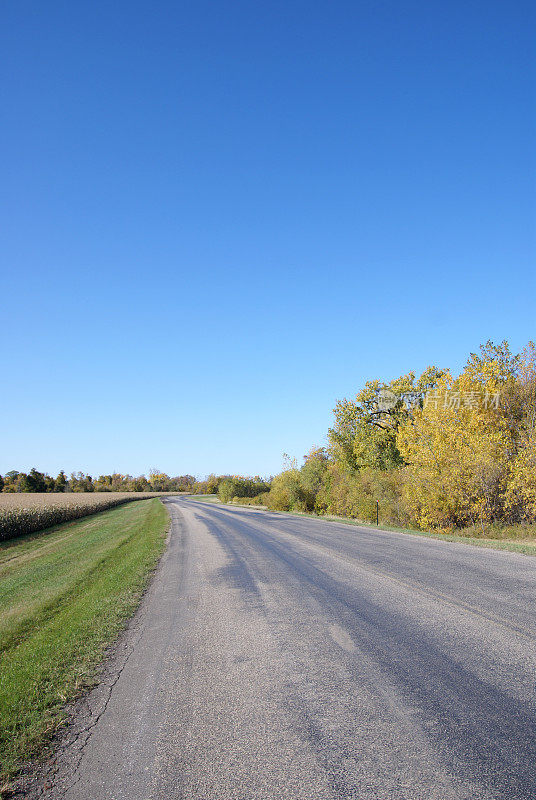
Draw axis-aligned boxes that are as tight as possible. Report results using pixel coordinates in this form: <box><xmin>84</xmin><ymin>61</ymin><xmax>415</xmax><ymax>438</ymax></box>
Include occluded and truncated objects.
<box><xmin>0</xmin><ymin>499</ymin><xmax>168</xmax><ymax>785</ymax></box>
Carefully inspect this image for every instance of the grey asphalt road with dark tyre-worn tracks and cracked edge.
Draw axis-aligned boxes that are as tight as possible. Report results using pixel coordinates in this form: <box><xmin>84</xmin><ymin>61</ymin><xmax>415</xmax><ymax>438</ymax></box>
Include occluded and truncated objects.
<box><xmin>33</xmin><ymin>499</ymin><xmax>536</xmax><ymax>800</ymax></box>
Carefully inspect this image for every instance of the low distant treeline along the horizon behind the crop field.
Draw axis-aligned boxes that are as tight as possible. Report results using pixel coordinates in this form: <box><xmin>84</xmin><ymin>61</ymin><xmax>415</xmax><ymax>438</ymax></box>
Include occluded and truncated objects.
<box><xmin>0</xmin><ymin>468</ymin><xmax>197</xmax><ymax>492</ymax></box>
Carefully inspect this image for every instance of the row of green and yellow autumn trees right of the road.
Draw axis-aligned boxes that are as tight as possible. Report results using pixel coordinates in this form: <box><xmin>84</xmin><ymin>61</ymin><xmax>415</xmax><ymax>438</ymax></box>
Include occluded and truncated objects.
<box><xmin>224</xmin><ymin>341</ymin><xmax>536</xmax><ymax>532</ymax></box>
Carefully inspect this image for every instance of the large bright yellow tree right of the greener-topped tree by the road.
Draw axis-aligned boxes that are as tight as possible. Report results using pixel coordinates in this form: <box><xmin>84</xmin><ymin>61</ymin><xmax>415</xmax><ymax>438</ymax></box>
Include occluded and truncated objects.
<box><xmin>397</xmin><ymin>342</ymin><xmax>518</xmax><ymax>528</ymax></box>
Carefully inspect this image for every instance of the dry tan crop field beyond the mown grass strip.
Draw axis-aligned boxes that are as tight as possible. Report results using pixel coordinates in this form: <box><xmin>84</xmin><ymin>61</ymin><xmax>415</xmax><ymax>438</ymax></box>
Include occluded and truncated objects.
<box><xmin>0</xmin><ymin>492</ymin><xmax>180</xmax><ymax>541</ymax></box>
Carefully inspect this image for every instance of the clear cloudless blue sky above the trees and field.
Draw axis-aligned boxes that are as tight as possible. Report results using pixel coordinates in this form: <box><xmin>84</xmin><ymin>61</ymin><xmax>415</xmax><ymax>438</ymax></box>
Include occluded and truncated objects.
<box><xmin>0</xmin><ymin>0</ymin><xmax>536</xmax><ymax>475</ymax></box>
